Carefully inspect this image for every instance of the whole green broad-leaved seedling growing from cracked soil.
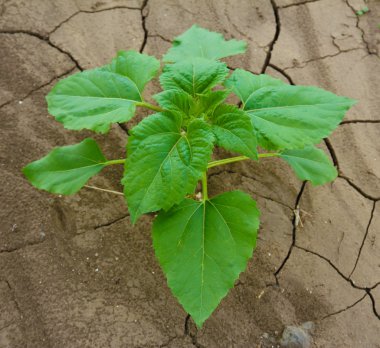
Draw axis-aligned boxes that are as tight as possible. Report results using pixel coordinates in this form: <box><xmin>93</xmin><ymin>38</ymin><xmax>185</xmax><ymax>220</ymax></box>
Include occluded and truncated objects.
<box><xmin>23</xmin><ymin>26</ymin><xmax>355</xmax><ymax>326</ymax></box>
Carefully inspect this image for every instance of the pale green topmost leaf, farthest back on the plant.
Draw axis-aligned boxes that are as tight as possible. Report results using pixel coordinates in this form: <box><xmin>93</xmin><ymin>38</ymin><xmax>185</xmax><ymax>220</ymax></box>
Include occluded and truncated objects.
<box><xmin>163</xmin><ymin>25</ymin><xmax>247</xmax><ymax>62</ymax></box>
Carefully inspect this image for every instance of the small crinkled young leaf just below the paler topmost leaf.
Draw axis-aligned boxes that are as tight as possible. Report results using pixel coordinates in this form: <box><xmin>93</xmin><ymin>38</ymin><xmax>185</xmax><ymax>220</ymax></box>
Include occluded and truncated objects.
<box><xmin>160</xmin><ymin>58</ymin><xmax>228</xmax><ymax>97</ymax></box>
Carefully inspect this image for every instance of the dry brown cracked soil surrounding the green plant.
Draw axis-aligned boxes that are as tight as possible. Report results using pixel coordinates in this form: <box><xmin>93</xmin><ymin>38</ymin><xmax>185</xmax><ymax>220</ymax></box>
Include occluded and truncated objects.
<box><xmin>0</xmin><ymin>0</ymin><xmax>380</xmax><ymax>348</ymax></box>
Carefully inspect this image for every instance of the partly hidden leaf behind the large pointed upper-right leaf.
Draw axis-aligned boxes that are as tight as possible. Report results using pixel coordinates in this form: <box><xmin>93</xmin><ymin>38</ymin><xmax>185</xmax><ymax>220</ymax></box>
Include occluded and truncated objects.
<box><xmin>224</xmin><ymin>69</ymin><xmax>285</xmax><ymax>106</ymax></box>
